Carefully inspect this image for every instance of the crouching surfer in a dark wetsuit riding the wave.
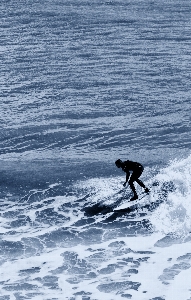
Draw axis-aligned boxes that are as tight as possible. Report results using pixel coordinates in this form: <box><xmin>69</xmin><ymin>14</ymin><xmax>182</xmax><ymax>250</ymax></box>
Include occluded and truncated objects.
<box><xmin>115</xmin><ymin>159</ymin><xmax>149</xmax><ymax>201</ymax></box>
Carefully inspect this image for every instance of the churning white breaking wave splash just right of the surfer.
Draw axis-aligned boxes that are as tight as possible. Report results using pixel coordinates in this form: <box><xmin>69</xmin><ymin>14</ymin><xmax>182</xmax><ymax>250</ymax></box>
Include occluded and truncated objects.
<box><xmin>150</xmin><ymin>156</ymin><xmax>191</xmax><ymax>236</ymax></box>
